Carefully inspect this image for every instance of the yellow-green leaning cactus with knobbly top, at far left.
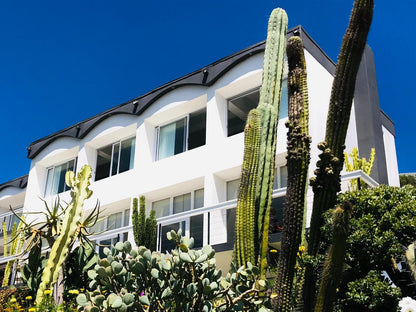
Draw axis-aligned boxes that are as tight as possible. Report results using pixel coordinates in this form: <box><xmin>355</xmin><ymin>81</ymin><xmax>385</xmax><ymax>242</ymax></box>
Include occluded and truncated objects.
<box><xmin>36</xmin><ymin>166</ymin><xmax>92</xmax><ymax>304</ymax></box>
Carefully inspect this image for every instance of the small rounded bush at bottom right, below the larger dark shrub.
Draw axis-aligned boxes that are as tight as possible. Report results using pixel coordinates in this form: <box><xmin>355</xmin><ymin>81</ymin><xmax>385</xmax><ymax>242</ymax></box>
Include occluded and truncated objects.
<box><xmin>341</xmin><ymin>271</ymin><xmax>401</xmax><ymax>312</ymax></box>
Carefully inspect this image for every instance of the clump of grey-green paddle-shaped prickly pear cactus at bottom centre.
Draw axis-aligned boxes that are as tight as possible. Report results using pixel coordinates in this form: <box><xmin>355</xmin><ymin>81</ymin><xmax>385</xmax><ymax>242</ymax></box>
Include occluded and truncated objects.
<box><xmin>77</xmin><ymin>231</ymin><xmax>270</xmax><ymax>312</ymax></box>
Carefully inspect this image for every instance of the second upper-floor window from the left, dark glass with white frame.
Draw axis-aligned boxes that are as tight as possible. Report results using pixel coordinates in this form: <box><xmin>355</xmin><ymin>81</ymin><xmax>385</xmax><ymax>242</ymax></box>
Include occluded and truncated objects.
<box><xmin>95</xmin><ymin>138</ymin><xmax>136</xmax><ymax>181</ymax></box>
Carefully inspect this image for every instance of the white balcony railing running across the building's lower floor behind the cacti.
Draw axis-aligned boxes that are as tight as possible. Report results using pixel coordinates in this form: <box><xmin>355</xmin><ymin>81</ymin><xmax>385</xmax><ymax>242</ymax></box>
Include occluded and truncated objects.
<box><xmin>0</xmin><ymin>170</ymin><xmax>378</xmax><ymax>264</ymax></box>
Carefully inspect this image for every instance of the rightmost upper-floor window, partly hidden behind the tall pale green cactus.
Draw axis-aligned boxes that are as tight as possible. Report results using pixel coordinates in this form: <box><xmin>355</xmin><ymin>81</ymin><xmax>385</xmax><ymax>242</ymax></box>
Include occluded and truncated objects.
<box><xmin>227</xmin><ymin>79</ymin><xmax>288</xmax><ymax>136</ymax></box>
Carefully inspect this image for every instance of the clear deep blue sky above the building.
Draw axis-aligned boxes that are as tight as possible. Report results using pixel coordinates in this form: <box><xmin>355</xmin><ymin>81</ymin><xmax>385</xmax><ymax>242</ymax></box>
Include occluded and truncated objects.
<box><xmin>0</xmin><ymin>0</ymin><xmax>416</xmax><ymax>183</ymax></box>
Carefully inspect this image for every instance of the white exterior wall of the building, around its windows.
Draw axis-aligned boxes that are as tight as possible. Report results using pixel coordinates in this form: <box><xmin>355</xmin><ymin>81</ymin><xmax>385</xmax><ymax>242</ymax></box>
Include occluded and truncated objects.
<box><xmin>17</xmin><ymin>47</ymin><xmax>372</xmax><ymax>245</ymax></box>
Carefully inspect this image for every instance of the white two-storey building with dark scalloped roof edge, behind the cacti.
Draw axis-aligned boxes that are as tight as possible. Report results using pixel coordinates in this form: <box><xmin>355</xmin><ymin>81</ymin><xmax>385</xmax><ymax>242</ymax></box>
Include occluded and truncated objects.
<box><xmin>0</xmin><ymin>27</ymin><xmax>399</xmax><ymax>270</ymax></box>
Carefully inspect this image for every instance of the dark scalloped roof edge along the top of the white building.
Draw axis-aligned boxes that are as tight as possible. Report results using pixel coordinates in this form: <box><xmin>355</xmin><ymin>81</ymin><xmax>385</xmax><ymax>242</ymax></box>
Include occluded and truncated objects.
<box><xmin>27</xmin><ymin>26</ymin><xmax>335</xmax><ymax>159</ymax></box>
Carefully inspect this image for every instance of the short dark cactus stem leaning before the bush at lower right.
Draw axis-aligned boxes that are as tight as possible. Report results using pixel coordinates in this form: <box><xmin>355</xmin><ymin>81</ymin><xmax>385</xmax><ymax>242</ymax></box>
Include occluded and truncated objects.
<box><xmin>315</xmin><ymin>202</ymin><xmax>352</xmax><ymax>312</ymax></box>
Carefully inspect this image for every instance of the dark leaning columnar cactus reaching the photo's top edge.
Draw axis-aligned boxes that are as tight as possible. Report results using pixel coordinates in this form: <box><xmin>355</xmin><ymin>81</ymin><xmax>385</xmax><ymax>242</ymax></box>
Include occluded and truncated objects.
<box><xmin>303</xmin><ymin>0</ymin><xmax>374</xmax><ymax>311</ymax></box>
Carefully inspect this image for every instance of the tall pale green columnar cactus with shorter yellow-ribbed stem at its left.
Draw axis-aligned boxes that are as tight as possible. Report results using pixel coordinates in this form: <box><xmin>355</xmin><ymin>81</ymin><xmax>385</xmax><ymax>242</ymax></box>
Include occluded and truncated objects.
<box><xmin>235</xmin><ymin>9</ymin><xmax>287</xmax><ymax>277</ymax></box>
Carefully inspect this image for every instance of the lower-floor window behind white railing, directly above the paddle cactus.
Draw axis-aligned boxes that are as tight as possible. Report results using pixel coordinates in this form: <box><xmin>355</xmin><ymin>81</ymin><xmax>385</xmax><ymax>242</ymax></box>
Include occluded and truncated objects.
<box><xmin>152</xmin><ymin>189</ymin><xmax>204</xmax><ymax>252</ymax></box>
